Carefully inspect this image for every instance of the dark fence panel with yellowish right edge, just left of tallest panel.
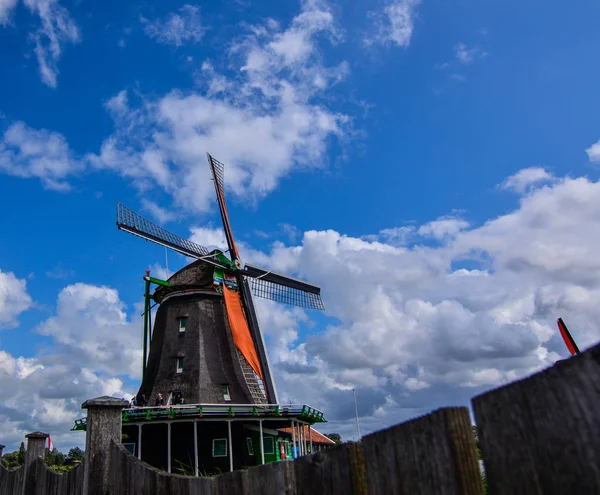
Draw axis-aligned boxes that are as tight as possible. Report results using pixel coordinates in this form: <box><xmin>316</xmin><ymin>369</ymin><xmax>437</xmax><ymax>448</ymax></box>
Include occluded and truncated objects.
<box><xmin>362</xmin><ymin>407</ymin><xmax>483</xmax><ymax>495</ymax></box>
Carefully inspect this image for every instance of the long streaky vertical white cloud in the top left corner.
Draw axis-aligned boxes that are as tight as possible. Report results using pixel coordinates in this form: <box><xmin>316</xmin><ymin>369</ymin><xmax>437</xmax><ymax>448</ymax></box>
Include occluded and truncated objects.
<box><xmin>23</xmin><ymin>0</ymin><xmax>80</xmax><ymax>88</ymax></box>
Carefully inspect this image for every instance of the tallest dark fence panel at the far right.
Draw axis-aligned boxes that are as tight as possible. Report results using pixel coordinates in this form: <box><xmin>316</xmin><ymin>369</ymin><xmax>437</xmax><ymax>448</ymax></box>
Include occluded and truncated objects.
<box><xmin>473</xmin><ymin>346</ymin><xmax>600</xmax><ymax>495</ymax></box>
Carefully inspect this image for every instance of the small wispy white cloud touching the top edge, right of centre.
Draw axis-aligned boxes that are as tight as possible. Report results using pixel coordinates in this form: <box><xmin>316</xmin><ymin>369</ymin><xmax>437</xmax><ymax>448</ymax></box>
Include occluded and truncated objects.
<box><xmin>365</xmin><ymin>0</ymin><xmax>421</xmax><ymax>47</ymax></box>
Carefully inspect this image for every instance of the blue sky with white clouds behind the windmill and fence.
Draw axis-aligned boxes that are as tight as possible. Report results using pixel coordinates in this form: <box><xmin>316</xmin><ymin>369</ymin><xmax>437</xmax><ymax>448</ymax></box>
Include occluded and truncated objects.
<box><xmin>0</xmin><ymin>0</ymin><xmax>600</xmax><ymax>448</ymax></box>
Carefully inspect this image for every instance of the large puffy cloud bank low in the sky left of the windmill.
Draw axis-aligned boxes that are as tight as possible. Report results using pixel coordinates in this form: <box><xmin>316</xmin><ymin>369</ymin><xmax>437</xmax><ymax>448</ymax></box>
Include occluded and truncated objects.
<box><xmin>0</xmin><ymin>282</ymin><xmax>141</xmax><ymax>451</ymax></box>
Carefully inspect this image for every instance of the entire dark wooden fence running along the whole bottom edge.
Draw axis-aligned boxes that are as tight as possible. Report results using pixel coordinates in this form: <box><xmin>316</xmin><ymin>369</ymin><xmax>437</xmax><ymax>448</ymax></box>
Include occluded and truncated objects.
<box><xmin>0</xmin><ymin>340</ymin><xmax>600</xmax><ymax>495</ymax></box>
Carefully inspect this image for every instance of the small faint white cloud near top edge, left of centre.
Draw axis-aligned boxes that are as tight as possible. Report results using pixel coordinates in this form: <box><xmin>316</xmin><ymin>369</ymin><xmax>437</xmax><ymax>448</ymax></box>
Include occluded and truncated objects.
<box><xmin>141</xmin><ymin>4</ymin><xmax>206</xmax><ymax>47</ymax></box>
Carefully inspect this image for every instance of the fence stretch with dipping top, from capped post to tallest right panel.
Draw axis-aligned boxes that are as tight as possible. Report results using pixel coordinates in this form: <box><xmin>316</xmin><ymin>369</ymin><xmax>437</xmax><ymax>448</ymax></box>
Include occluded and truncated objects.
<box><xmin>110</xmin><ymin>408</ymin><xmax>483</xmax><ymax>495</ymax></box>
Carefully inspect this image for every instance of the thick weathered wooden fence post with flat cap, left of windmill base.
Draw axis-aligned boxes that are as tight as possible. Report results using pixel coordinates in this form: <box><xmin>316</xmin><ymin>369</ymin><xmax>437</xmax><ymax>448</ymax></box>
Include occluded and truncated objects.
<box><xmin>81</xmin><ymin>396</ymin><xmax>129</xmax><ymax>495</ymax></box>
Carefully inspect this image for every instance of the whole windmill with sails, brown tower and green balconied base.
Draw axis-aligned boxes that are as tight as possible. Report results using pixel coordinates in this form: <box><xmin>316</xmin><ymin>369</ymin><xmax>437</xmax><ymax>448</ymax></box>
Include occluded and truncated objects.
<box><xmin>71</xmin><ymin>155</ymin><xmax>325</xmax><ymax>475</ymax></box>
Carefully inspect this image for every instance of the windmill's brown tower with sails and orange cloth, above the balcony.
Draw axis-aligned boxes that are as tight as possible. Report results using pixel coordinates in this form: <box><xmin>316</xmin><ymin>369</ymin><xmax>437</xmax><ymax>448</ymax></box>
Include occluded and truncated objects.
<box><xmin>117</xmin><ymin>154</ymin><xmax>324</xmax><ymax>404</ymax></box>
